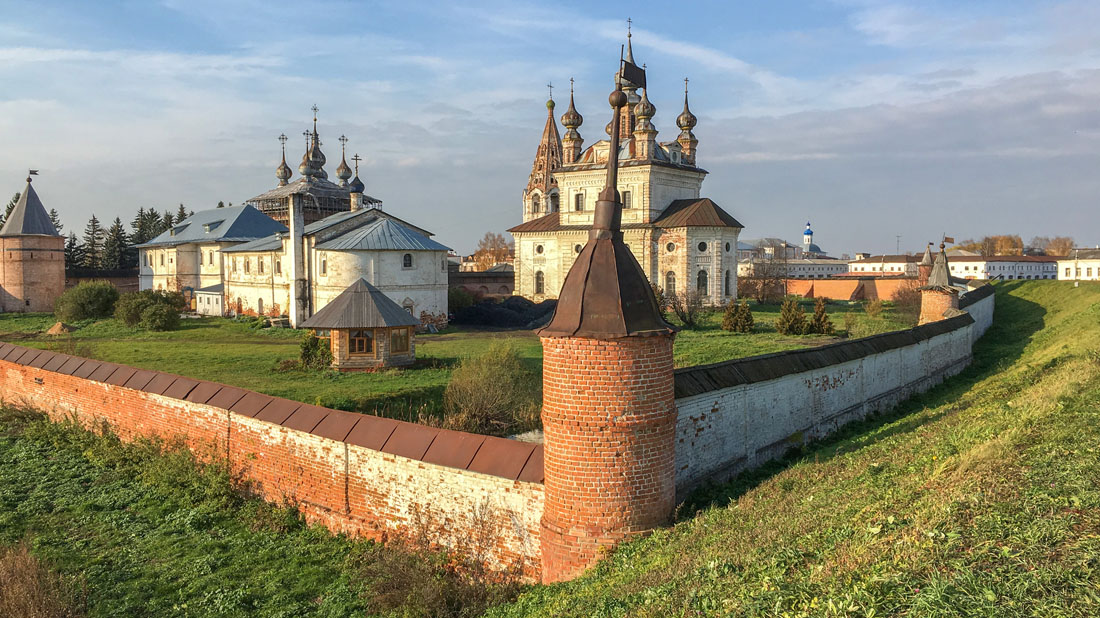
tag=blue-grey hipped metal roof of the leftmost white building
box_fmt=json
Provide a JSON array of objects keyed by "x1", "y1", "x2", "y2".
[{"x1": 138, "y1": 205, "x2": 286, "y2": 247}]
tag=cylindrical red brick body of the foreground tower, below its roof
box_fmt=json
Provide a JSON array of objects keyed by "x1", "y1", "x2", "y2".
[{"x1": 542, "y1": 335, "x2": 677, "y2": 583}]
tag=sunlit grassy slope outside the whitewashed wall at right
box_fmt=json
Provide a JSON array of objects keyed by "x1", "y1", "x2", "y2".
[{"x1": 492, "y1": 282, "x2": 1100, "y2": 617}]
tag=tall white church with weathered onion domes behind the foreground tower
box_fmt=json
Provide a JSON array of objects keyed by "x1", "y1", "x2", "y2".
[{"x1": 508, "y1": 40, "x2": 743, "y2": 305}]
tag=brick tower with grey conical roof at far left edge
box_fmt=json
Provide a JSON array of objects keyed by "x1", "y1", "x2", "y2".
[{"x1": 0, "y1": 170, "x2": 65, "y2": 313}]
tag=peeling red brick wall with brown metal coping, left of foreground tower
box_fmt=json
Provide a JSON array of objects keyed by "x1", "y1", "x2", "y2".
[{"x1": 0, "y1": 343, "x2": 543, "y2": 578}]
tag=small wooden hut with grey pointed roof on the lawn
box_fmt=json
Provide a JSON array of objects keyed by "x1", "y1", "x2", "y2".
[{"x1": 301, "y1": 278, "x2": 420, "y2": 371}]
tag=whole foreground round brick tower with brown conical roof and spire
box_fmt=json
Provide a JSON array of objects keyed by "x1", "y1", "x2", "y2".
[{"x1": 539, "y1": 76, "x2": 677, "y2": 583}]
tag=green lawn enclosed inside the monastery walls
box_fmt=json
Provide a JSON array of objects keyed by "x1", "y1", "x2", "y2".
[{"x1": 0, "y1": 304, "x2": 906, "y2": 420}]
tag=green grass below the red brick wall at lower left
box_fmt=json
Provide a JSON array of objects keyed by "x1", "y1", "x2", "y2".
[{"x1": 0, "y1": 408, "x2": 514, "y2": 618}]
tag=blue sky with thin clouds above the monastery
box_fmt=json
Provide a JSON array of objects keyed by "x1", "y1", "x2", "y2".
[{"x1": 0, "y1": 0, "x2": 1100, "y2": 256}]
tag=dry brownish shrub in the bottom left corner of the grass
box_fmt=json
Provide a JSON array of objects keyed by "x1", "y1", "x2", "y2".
[{"x1": 0, "y1": 544, "x2": 87, "y2": 618}]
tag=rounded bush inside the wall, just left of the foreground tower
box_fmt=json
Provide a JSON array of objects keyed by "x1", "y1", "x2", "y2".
[{"x1": 443, "y1": 341, "x2": 542, "y2": 435}]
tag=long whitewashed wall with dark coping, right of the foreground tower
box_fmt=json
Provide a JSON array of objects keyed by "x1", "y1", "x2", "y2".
[{"x1": 675, "y1": 286, "x2": 993, "y2": 497}]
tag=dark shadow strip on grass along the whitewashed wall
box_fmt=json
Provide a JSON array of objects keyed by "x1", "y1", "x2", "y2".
[{"x1": 677, "y1": 282, "x2": 1046, "y2": 520}]
